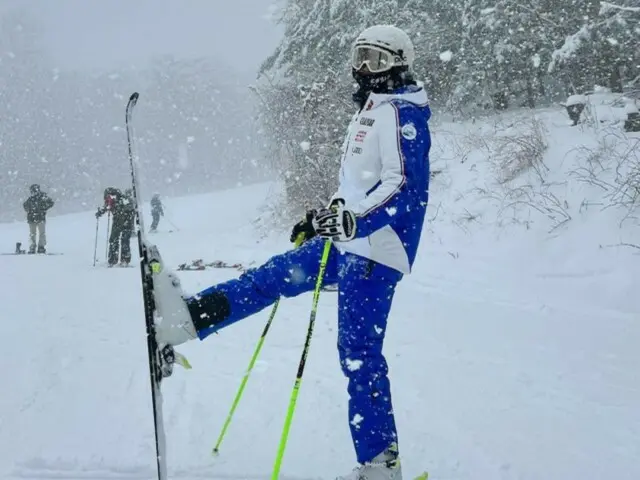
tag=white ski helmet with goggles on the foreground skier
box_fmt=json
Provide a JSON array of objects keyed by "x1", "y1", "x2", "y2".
[{"x1": 351, "y1": 25, "x2": 415, "y2": 73}]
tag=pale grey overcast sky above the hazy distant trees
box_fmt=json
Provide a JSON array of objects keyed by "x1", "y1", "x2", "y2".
[{"x1": 0, "y1": 0, "x2": 281, "y2": 74}]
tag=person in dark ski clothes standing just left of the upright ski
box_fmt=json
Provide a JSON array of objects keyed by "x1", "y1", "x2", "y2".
[{"x1": 96, "y1": 187, "x2": 135, "y2": 267}]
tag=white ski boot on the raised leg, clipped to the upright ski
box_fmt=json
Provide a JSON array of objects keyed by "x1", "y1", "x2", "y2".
[{"x1": 148, "y1": 246, "x2": 198, "y2": 348}]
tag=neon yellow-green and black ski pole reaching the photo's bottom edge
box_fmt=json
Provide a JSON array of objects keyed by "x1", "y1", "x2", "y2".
[{"x1": 271, "y1": 240, "x2": 331, "y2": 480}]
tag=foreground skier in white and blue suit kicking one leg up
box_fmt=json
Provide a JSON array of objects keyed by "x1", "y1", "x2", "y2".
[{"x1": 154, "y1": 25, "x2": 431, "y2": 480}]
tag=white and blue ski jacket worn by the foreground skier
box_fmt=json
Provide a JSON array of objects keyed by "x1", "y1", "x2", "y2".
[{"x1": 333, "y1": 86, "x2": 431, "y2": 274}]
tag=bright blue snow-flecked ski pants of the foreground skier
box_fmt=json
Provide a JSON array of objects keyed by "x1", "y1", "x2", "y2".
[{"x1": 190, "y1": 237, "x2": 402, "y2": 463}]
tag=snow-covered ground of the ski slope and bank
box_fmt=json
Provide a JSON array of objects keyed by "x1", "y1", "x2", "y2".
[{"x1": 0, "y1": 105, "x2": 640, "y2": 480}]
